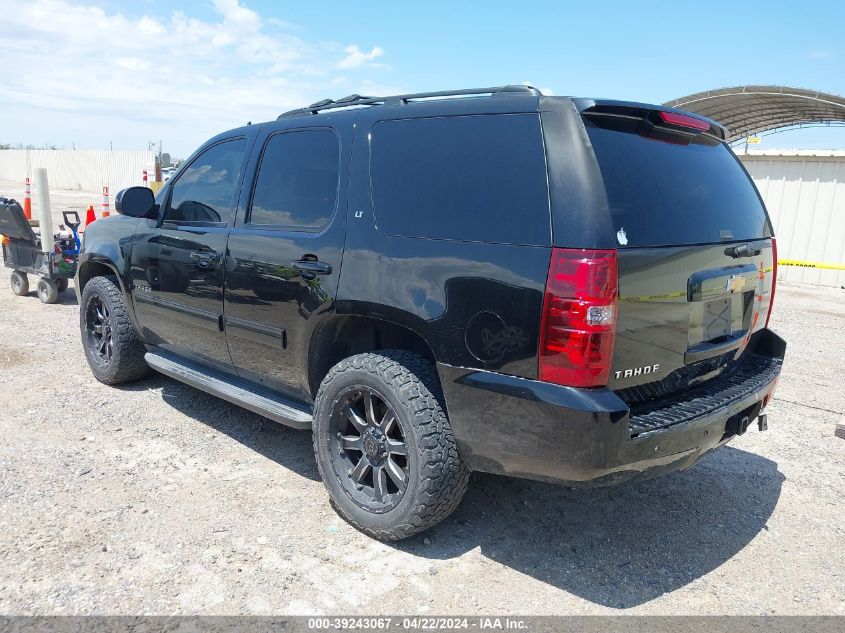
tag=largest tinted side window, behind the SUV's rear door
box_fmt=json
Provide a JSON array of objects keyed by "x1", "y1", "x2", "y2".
[{"x1": 371, "y1": 114, "x2": 551, "y2": 245}]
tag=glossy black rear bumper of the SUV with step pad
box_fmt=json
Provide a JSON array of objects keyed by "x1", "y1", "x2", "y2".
[{"x1": 438, "y1": 330, "x2": 786, "y2": 485}]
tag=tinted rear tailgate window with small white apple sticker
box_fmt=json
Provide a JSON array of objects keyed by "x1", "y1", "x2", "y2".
[{"x1": 585, "y1": 117, "x2": 771, "y2": 246}]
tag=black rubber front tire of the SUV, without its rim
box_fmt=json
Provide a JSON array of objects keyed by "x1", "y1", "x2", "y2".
[{"x1": 79, "y1": 276, "x2": 152, "y2": 385}]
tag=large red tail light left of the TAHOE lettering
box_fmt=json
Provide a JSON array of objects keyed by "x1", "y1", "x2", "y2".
[{"x1": 539, "y1": 248, "x2": 619, "y2": 387}]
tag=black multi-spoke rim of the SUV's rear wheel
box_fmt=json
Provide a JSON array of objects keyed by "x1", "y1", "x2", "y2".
[{"x1": 329, "y1": 387, "x2": 410, "y2": 513}]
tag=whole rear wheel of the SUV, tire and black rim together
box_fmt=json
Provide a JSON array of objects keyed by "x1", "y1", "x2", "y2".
[{"x1": 314, "y1": 350, "x2": 469, "y2": 541}]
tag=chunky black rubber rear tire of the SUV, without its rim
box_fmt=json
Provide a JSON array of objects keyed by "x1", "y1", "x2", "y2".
[{"x1": 314, "y1": 350, "x2": 470, "y2": 541}]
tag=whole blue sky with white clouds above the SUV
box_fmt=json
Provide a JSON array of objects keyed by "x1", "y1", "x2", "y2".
[{"x1": 0, "y1": 0, "x2": 845, "y2": 156}]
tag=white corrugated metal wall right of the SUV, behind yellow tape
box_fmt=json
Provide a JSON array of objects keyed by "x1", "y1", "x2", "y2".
[{"x1": 739, "y1": 152, "x2": 845, "y2": 287}]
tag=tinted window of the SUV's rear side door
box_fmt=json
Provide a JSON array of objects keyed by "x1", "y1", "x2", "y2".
[{"x1": 249, "y1": 130, "x2": 340, "y2": 228}]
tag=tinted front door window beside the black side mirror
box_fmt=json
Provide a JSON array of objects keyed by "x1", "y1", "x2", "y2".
[{"x1": 164, "y1": 139, "x2": 246, "y2": 224}]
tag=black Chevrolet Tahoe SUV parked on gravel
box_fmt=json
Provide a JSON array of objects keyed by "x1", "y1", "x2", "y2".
[{"x1": 76, "y1": 86, "x2": 785, "y2": 539}]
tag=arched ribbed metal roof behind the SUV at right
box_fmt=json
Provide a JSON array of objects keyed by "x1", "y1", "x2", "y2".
[{"x1": 663, "y1": 86, "x2": 845, "y2": 143}]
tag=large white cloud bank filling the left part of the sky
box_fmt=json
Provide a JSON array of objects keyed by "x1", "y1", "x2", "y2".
[{"x1": 0, "y1": 0, "x2": 384, "y2": 155}]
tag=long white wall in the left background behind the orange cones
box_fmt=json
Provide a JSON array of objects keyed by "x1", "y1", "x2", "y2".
[{"x1": 0, "y1": 149, "x2": 155, "y2": 195}]
